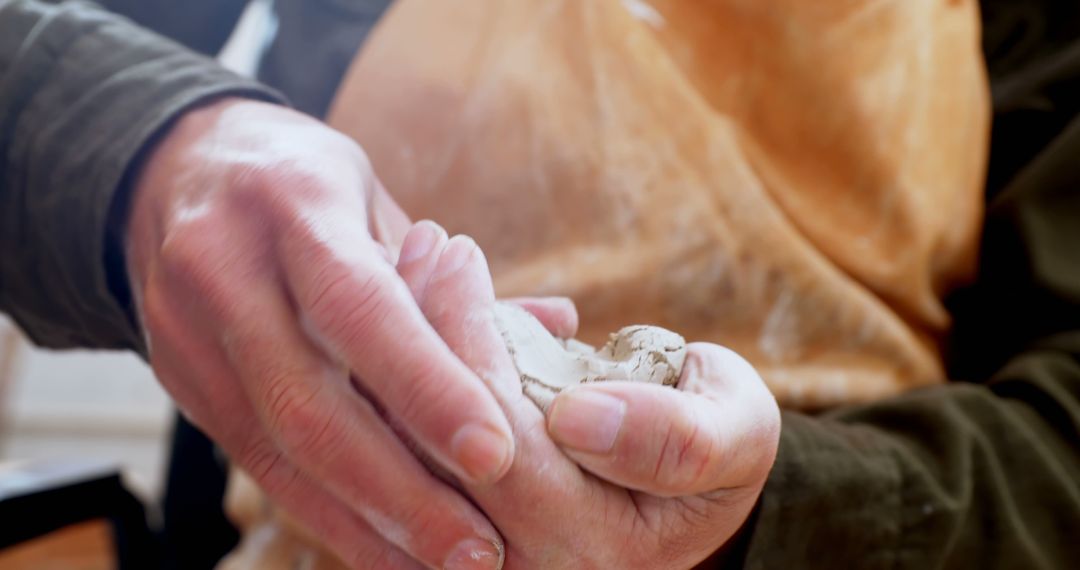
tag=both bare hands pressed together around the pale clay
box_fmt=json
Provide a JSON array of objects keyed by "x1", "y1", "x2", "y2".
[{"x1": 127, "y1": 99, "x2": 780, "y2": 568}]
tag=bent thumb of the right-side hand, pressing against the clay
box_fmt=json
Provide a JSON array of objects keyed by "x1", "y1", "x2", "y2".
[{"x1": 548, "y1": 344, "x2": 779, "y2": 497}]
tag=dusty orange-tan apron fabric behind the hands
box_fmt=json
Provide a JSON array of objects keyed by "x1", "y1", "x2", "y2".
[{"x1": 329, "y1": 0, "x2": 989, "y2": 407}]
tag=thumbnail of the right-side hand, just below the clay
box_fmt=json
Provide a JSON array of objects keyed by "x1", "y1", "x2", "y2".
[{"x1": 548, "y1": 389, "x2": 626, "y2": 453}]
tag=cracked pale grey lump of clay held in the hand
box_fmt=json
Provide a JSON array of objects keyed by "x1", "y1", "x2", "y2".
[{"x1": 495, "y1": 303, "x2": 686, "y2": 411}]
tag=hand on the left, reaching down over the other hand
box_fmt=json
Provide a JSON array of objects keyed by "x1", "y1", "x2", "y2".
[{"x1": 126, "y1": 99, "x2": 572, "y2": 568}]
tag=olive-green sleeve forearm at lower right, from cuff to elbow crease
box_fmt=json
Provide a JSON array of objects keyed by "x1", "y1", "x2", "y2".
[{"x1": 745, "y1": 334, "x2": 1080, "y2": 570}]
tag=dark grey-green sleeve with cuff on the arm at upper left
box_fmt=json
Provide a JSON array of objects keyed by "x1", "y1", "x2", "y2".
[{"x1": 0, "y1": 0, "x2": 278, "y2": 349}]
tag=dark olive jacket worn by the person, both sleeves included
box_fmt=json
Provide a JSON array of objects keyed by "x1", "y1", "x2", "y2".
[{"x1": 0, "y1": 0, "x2": 1080, "y2": 570}]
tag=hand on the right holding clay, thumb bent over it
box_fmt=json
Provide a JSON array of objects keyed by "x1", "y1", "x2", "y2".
[{"x1": 397, "y1": 222, "x2": 780, "y2": 569}]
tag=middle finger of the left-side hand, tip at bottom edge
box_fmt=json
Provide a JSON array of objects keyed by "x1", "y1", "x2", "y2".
[{"x1": 227, "y1": 282, "x2": 501, "y2": 567}]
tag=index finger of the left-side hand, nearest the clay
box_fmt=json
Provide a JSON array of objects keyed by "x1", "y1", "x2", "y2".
[{"x1": 280, "y1": 213, "x2": 514, "y2": 484}]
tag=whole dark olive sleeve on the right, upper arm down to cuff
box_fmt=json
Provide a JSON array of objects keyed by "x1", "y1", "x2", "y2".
[{"x1": 729, "y1": 0, "x2": 1080, "y2": 570}]
